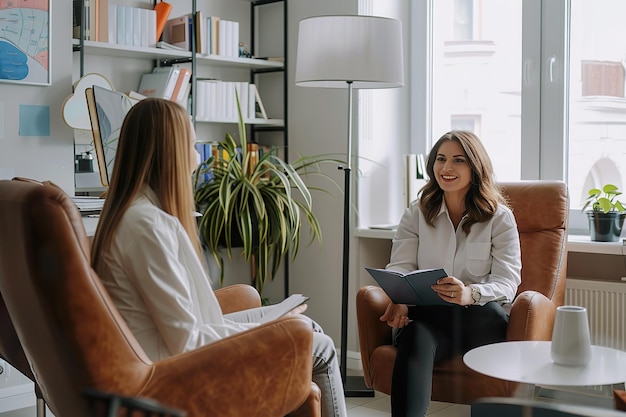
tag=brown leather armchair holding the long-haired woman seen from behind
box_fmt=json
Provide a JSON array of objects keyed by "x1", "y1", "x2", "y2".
[{"x1": 0, "y1": 180, "x2": 321, "y2": 417}]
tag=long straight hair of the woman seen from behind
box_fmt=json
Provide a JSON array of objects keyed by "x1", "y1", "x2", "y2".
[{"x1": 91, "y1": 98, "x2": 201, "y2": 271}]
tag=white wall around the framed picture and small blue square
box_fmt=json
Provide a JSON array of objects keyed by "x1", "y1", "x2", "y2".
[{"x1": 0, "y1": 1, "x2": 74, "y2": 194}]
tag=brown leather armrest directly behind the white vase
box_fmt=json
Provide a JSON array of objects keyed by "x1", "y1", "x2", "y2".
[{"x1": 506, "y1": 291, "x2": 556, "y2": 341}]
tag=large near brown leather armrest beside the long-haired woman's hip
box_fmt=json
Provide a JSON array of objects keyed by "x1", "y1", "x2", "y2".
[{"x1": 145, "y1": 316, "x2": 313, "y2": 417}]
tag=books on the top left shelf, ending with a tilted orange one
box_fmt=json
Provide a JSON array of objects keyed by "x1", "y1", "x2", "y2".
[{"x1": 74, "y1": 0, "x2": 171, "y2": 47}]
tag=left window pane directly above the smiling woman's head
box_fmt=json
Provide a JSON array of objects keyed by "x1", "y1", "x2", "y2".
[{"x1": 427, "y1": 0, "x2": 522, "y2": 180}]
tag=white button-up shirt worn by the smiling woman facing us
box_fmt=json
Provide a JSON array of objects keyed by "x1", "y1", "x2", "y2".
[{"x1": 387, "y1": 200, "x2": 522, "y2": 313}]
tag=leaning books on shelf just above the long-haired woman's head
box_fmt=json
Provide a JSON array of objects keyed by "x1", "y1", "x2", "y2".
[{"x1": 137, "y1": 65, "x2": 191, "y2": 107}]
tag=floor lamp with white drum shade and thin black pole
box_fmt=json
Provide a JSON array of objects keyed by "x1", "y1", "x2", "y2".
[{"x1": 296, "y1": 15, "x2": 404, "y2": 397}]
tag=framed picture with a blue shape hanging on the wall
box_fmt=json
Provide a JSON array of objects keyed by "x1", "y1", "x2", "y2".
[{"x1": 0, "y1": 0, "x2": 52, "y2": 85}]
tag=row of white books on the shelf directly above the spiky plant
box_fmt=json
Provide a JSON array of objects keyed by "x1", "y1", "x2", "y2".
[{"x1": 196, "y1": 79, "x2": 268, "y2": 122}]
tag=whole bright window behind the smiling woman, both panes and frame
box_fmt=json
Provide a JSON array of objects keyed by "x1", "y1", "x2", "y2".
[{"x1": 411, "y1": 0, "x2": 626, "y2": 233}]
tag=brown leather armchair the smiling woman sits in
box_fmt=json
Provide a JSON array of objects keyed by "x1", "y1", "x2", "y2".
[{"x1": 356, "y1": 181, "x2": 569, "y2": 404}]
